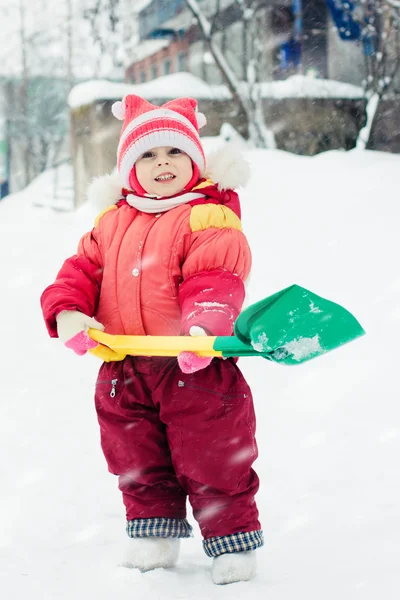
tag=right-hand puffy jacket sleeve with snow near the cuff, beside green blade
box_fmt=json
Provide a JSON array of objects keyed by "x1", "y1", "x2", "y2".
[{"x1": 179, "y1": 205, "x2": 251, "y2": 335}]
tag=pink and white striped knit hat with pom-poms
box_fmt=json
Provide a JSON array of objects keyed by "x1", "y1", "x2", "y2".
[{"x1": 111, "y1": 94, "x2": 207, "y2": 189}]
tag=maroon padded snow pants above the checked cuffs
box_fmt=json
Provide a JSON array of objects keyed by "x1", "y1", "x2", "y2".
[{"x1": 95, "y1": 357, "x2": 260, "y2": 539}]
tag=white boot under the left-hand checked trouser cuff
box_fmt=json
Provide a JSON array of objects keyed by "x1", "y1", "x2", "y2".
[{"x1": 123, "y1": 537, "x2": 181, "y2": 572}]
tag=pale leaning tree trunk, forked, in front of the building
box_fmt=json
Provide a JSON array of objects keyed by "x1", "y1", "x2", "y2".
[{"x1": 185, "y1": 0, "x2": 276, "y2": 148}]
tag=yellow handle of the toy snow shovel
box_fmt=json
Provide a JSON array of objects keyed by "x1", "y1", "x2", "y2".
[{"x1": 88, "y1": 329, "x2": 222, "y2": 362}]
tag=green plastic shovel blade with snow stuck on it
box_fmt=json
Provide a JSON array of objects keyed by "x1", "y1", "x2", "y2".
[{"x1": 228, "y1": 285, "x2": 365, "y2": 365}]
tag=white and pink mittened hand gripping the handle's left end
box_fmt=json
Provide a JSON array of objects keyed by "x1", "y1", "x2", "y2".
[{"x1": 56, "y1": 310, "x2": 104, "y2": 356}]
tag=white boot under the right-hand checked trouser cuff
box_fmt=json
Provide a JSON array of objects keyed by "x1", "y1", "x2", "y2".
[{"x1": 211, "y1": 550, "x2": 257, "y2": 585}]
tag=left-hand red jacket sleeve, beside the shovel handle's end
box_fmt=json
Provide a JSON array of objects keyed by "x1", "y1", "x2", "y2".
[{"x1": 40, "y1": 229, "x2": 103, "y2": 337}]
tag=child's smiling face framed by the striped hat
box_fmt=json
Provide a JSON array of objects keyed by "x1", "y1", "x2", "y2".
[{"x1": 136, "y1": 146, "x2": 193, "y2": 196}]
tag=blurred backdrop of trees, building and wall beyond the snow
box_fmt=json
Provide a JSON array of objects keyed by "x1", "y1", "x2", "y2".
[{"x1": 0, "y1": 0, "x2": 400, "y2": 210}]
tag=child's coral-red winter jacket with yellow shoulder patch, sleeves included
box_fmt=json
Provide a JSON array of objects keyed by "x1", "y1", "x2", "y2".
[{"x1": 41, "y1": 182, "x2": 251, "y2": 337}]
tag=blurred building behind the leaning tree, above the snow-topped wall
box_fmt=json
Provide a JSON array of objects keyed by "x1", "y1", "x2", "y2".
[{"x1": 125, "y1": 0, "x2": 363, "y2": 85}]
